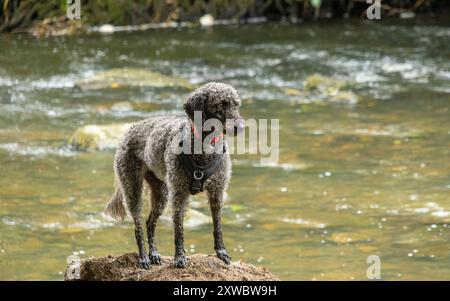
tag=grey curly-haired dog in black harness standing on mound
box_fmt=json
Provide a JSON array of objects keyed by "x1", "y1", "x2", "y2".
[{"x1": 105, "y1": 83, "x2": 244, "y2": 269}]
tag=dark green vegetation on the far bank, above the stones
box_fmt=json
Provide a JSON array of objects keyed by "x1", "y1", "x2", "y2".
[{"x1": 0, "y1": 0, "x2": 450, "y2": 32}]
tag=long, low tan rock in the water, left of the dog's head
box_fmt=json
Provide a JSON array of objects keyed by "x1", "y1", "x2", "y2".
[{"x1": 75, "y1": 68, "x2": 195, "y2": 90}]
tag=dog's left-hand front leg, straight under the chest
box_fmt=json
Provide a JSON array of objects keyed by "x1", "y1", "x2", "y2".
[{"x1": 173, "y1": 193, "x2": 189, "y2": 268}]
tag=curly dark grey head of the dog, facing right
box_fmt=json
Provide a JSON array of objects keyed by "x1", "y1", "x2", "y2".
[{"x1": 183, "y1": 82, "x2": 245, "y2": 135}]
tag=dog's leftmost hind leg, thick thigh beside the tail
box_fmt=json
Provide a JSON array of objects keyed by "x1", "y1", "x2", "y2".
[{"x1": 115, "y1": 151, "x2": 150, "y2": 269}]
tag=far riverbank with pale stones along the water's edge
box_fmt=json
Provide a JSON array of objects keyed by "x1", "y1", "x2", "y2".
[{"x1": 0, "y1": 0, "x2": 450, "y2": 36}]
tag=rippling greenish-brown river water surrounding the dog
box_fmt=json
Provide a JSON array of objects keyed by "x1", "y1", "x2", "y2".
[{"x1": 0, "y1": 23, "x2": 450, "y2": 280}]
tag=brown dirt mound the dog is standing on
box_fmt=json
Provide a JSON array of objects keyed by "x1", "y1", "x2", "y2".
[{"x1": 64, "y1": 253, "x2": 279, "y2": 281}]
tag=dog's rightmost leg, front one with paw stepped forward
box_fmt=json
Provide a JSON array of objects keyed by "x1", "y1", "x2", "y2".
[{"x1": 208, "y1": 191, "x2": 231, "y2": 264}]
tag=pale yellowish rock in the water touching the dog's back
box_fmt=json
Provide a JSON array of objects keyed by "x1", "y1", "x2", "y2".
[{"x1": 69, "y1": 123, "x2": 132, "y2": 151}]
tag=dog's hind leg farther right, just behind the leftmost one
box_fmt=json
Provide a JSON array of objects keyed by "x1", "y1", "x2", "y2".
[{"x1": 144, "y1": 171, "x2": 167, "y2": 264}]
